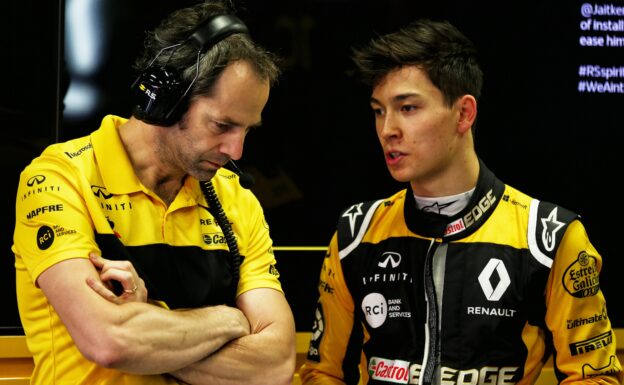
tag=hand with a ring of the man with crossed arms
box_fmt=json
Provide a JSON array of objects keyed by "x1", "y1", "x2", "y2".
[{"x1": 86, "y1": 253, "x2": 147, "y2": 305}]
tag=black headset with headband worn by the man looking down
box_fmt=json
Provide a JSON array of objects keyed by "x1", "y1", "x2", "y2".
[{"x1": 130, "y1": 14, "x2": 249, "y2": 126}]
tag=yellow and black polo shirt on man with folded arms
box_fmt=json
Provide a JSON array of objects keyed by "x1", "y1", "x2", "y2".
[{"x1": 12, "y1": 115, "x2": 281, "y2": 385}]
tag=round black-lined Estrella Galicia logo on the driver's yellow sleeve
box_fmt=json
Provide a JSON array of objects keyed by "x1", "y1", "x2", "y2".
[{"x1": 562, "y1": 251, "x2": 600, "y2": 298}]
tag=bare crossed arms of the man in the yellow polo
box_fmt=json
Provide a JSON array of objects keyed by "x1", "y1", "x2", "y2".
[{"x1": 37, "y1": 252, "x2": 295, "y2": 384}]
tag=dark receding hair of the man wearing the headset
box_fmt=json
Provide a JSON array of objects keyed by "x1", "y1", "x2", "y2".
[{"x1": 134, "y1": 0, "x2": 280, "y2": 98}]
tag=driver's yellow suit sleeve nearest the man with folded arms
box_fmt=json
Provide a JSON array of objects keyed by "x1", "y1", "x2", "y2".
[{"x1": 299, "y1": 234, "x2": 361, "y2": 385}]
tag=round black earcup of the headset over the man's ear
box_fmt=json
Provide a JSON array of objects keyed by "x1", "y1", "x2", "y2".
[{"x1": 131, "y1": 66, "x2": 185, "y2": 126}]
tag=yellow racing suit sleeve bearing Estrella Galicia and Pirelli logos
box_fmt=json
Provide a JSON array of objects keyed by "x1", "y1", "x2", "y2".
[{"x1": 546, "y1": 220, "x2": 624, "y2": 384}]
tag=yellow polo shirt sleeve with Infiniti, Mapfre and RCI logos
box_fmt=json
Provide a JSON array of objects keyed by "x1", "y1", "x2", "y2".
[{"x1": 12, "y1": 151, "x2": 98, "y2": 282}]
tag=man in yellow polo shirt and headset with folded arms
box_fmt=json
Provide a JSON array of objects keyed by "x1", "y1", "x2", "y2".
[{"x1": 13, "y1": 2, "x2": 295, "y2": 385}]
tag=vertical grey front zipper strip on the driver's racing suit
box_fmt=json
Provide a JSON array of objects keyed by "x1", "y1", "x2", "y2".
[{"x1": 419, "y1": 239, "x2": 439, "y2": 385}]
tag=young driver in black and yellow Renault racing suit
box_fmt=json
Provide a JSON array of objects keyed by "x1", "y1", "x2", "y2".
[{"x1": 301, "y1": 20, "x2": 622, "y2": 385}]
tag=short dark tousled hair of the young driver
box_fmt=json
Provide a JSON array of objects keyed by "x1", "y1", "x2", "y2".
[{"x1": 352, "y1": 19, "x2": 483, "y2": 106}]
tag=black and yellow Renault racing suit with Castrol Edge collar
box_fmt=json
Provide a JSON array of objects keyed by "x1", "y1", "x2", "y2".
[{"x1": 300, "y1": 162, "x2": 623, "y2": 385}]
